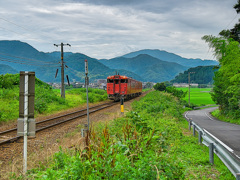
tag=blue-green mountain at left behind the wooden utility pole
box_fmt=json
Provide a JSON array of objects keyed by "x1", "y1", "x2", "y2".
[{"x1": 0, "y1": 41, "x2": 143, "y2": 82}]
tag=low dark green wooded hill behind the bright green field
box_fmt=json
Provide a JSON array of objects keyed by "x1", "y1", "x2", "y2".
[{"x1": 171, "y1": 66, "x2": 217, "y2": 84}]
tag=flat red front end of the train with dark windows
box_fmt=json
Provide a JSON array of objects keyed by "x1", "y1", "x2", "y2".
[{"x1": 107, "y1": 75, "x2": 128, "y2": 101}]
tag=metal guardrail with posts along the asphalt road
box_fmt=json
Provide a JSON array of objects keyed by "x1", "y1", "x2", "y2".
[{"x1": 185, "y1": 112, "x2": 240, "y2": 180}]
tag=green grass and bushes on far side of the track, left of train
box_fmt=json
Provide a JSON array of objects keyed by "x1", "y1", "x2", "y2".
[{"x1": 0, "y1": 74, "x2": 107, "y2": 122}]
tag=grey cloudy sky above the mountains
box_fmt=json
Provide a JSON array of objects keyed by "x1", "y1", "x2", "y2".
[{"x1": 0, "y1": 0, "x2": 239, "y2": 59}]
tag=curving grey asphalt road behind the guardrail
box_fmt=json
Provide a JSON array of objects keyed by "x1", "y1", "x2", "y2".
[{"x1": 185, "y1": 107, "x2": 240, "y2": 159}]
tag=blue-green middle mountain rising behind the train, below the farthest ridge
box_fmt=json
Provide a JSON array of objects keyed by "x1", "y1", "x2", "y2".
[{"x1": 100, "y1": 54, "x2": 187, "y2": 82}]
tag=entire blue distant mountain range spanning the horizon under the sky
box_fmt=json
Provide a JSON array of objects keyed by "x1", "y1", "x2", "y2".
[{"x1": 0, "y1": 41, "x2": 218, "y2": 82}]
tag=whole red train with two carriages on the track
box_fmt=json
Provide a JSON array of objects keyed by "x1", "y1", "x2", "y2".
[{"x1": 107, "y1": 75, "x2": 142, "y2": 101}]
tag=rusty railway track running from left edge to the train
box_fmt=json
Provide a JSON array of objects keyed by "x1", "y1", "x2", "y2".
[{"x1": 0, "y1": 102, "x2": 116, "y2": 146}]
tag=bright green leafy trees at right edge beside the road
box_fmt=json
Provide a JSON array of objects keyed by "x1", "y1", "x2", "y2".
[{"x1": 202, "y1": 35, "x2": 240, "y2": 118}]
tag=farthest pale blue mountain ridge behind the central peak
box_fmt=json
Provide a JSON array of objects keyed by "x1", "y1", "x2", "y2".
[{"x1": 122, "y1": 49, "x2": 218, "y2": 67}]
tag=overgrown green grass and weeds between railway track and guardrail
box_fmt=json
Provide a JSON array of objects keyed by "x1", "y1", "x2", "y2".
[{"x1": 12, "y1": 91, "x2": 234, "y2": 179}]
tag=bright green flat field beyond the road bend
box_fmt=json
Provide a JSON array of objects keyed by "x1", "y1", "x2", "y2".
[{"x1": 178, "y1": 88, "x2": 215, "y2": 106}]
